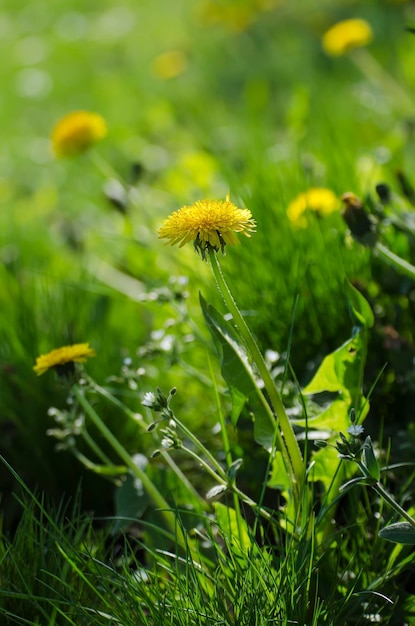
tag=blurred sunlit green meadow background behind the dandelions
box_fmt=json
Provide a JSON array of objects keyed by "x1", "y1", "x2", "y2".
[{"x1": 0, "y1": 0, "x2": 415, "y2": 528}]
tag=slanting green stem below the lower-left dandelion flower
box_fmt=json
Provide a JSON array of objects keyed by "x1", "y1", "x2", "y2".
[{"x1": 72, "y1": 385, "x2": 181, "y2": 537}]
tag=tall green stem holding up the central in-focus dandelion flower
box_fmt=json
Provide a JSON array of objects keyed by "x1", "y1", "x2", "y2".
[{"x1": 208, "y1": 249, "x2": 304, "y2": 493}]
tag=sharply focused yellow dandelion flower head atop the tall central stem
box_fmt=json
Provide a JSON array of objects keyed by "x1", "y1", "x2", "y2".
[{"x1": 158, "y1": 196, "x2": 256, "y2": 259}]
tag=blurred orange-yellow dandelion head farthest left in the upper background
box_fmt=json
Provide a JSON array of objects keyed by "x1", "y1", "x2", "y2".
[{"x1": 51, "y1": 111, "x2": 107, "y2": 157}]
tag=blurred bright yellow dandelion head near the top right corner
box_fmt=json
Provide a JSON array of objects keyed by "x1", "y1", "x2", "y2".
[{"x1": 322, "y1": 18, "x2": 373, "y2": 57}]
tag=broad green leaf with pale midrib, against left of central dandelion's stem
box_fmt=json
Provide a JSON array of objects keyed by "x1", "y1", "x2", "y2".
[{"x1": 200, "y1": 295, "x2": 281, "y2": 450}]
